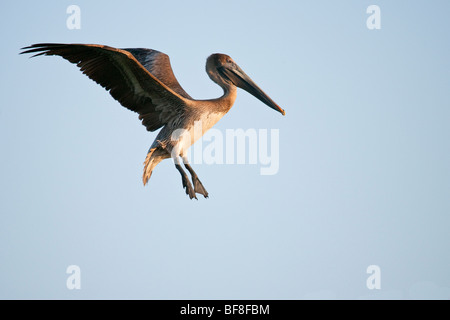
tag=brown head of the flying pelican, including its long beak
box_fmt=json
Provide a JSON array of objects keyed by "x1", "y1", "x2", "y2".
[{"x1": 206, "y1": 53, "x2": 285, "y2": 116}]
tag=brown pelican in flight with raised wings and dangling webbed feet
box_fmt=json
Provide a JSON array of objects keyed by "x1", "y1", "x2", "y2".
[{"x1": 21, "y1": 43, "x2": 285, "y2": 199}]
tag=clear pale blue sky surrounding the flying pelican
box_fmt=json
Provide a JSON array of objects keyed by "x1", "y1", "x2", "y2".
[{"x1": 0, "y1": 0, "x2": 450, "y2": 299}]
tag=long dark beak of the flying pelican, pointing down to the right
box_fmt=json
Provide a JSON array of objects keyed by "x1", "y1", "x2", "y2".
[{"x1": 219, "y1": 64, "x2": 286, "y2": 116}]
